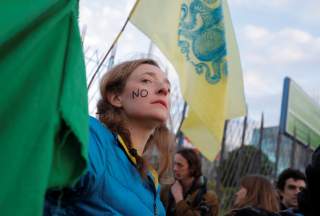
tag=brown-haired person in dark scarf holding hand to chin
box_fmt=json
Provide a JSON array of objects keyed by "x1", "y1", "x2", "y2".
[{"x1": 161, "y1": 148, "x2": 219, "y2": 216}]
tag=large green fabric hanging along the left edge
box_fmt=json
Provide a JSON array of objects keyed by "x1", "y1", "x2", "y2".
[{"x1": 0, "y1": 0, "x2": 88, "y2": 216}]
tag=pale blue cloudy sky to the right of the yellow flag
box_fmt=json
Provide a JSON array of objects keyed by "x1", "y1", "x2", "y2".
[{"x1": 229, "y1": 0, "x2": 320, "y2": 124}]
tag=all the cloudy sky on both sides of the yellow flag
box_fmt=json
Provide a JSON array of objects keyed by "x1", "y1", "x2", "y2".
[{"x1": 80, "y1": 0, "x2": 320, "y2": 125}]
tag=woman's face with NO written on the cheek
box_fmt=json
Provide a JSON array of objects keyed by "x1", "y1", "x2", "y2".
[{"x1": 115, "y1": 64, "x2": 170, "y2": 124}]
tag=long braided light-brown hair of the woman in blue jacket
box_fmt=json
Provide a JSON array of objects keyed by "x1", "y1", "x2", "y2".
[{"x1": 97, "y1": 58, "x2": 174, "y2": 179}]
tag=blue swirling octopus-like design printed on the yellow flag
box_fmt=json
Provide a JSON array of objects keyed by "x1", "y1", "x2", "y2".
[{"x1": 178, "y1": 0, "x2": 227, "y2": 84}]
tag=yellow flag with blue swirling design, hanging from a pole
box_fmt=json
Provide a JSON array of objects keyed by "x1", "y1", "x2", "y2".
[{"x1": 131, "y1": 0, "x2": 245, "y2": 160}]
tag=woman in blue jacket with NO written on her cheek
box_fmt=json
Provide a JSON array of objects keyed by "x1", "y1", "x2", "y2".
[{"x1": 45, "y1": 59, "x2": 171, "y2": 216}]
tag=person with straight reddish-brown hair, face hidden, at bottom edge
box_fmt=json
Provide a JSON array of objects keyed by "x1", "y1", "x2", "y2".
[{"x1": 227, "y1": 175, "x2": 279, "y2": 216}]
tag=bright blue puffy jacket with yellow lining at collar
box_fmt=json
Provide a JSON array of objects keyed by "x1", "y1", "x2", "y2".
[{"x1": 44, "y1": 117, "x2": 165, "y2": 216}]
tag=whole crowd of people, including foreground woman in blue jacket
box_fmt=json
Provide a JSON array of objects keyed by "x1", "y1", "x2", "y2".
[{"x1": 44, "y1": 59, "x2": 320, "y2": 216}]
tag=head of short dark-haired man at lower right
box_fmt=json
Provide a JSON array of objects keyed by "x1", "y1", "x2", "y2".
[{"x1": 277, "y1": 168, "x2": 306, "y2": 211}]
